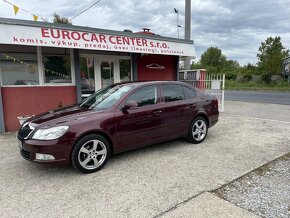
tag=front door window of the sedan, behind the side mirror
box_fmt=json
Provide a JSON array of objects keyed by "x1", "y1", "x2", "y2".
[{"x1": 127, "y1": 86, "x2": 157, "y2": 107}]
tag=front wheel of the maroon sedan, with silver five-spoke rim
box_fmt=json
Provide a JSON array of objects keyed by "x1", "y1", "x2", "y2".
[{"x1": 71, "y1": 134, "x2": 110, "y2": 173}]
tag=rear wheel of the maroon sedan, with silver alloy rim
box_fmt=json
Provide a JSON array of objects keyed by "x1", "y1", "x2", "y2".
[{"x1": 188, "y1": 116, "x2": 208, "y2": 144}]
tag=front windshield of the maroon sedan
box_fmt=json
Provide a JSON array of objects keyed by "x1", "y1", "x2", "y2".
[{"x1": 80, "y1": 85, "x2": 133, "y2": 110}]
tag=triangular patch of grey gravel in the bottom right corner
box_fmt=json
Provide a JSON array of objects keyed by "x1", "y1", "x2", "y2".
[{"x1": 214, "y1": 153, "x2": 290, "y2": 218}]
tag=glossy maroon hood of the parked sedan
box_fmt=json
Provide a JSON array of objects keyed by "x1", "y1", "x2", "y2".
[{"x1": 27, "y1": 105, "x2": 95, "y2": 127}]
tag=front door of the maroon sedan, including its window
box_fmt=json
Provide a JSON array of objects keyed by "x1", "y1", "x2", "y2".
[{"x1": 115, "y1": 85, "x2": 162, "y2": 150}]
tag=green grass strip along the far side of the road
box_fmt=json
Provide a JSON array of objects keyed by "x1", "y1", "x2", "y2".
[{"x1": 225, "y1": 80, "x2": 290, "y2": 91}]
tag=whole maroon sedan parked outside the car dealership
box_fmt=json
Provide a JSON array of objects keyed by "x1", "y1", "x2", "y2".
[{"x1": 18, "y1": 81, "x2": 219, "y2": 173}]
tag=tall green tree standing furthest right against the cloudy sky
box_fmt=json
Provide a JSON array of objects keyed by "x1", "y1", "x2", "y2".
[{"x1": 257, "y1": 36, "x2": 289, "y2": 75}]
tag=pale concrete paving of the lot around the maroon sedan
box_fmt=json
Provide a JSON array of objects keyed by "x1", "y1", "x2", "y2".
[{"x1": 0, "y1": 102, "x2": 290, "y2": 217}]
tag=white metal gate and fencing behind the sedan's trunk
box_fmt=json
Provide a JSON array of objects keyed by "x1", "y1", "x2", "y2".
[{"x1": 178, "y1": 70, "x2": 225, "y2": 112}]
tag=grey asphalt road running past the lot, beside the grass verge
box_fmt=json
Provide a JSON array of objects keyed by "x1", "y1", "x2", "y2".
[{"x1": 225, "y1": 90, "x2": 290, "y2": 105}]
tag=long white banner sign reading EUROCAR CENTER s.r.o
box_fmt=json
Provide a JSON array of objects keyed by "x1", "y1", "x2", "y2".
[{"x1": 0, "y1": 24, "x2": 196, "y2": 57}]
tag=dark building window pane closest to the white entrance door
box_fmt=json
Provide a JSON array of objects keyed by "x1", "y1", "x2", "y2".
[{"x1": 42, "y1": 47, "x2": 72, "y2": 83}]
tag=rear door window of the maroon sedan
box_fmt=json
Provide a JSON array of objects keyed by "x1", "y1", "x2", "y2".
[{"x1": 162, "y1": 85, "x2": 184, "y2": 102}]
